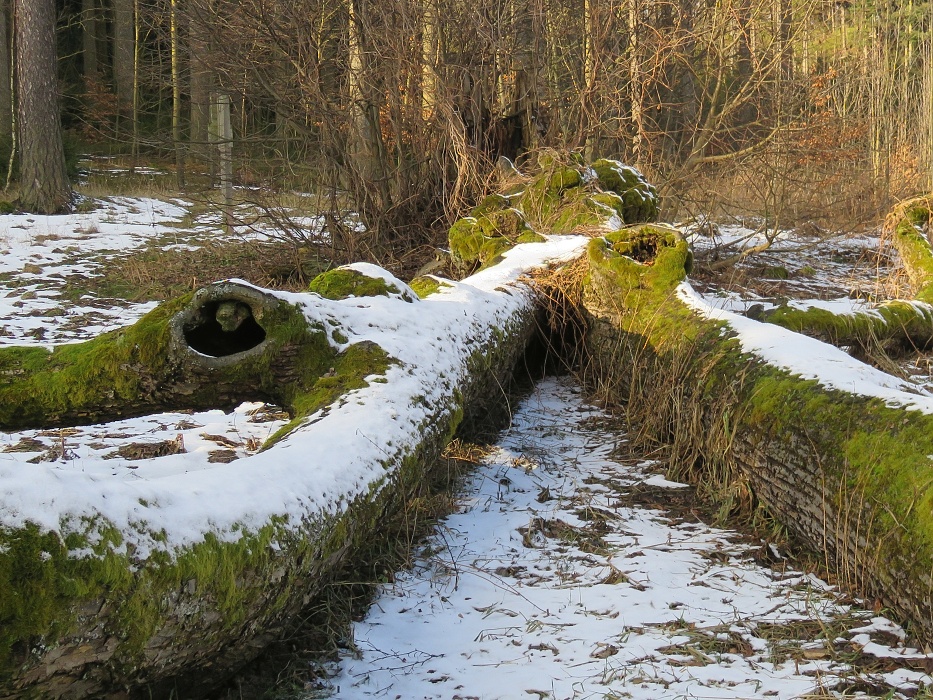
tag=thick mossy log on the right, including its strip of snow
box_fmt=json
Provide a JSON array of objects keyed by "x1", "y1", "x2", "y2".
[{"x1": 584, "y1": 225, "x2": 933, "y2": 644}]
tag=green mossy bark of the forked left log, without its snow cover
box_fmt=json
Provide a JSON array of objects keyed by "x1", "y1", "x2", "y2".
[{"x1": 0, "y1": 266, "x2": 536, "y2": 698}]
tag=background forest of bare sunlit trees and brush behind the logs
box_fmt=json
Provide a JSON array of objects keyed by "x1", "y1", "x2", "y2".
[{"x1": 0, "y1": 0, "x2": 933, "y2": 258}]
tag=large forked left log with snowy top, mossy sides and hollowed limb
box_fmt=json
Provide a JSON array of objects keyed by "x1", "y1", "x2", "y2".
[{"x1": 0, "y1": 238, "x2": 583, "y2": 697}]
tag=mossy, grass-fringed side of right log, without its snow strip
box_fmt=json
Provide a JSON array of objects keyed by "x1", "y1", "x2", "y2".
[{"x1": 585, "y1": 226, "x2": 933, "y2": 639}]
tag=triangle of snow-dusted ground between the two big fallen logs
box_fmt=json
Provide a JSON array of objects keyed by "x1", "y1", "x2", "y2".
[{"x1": 316, "y1": 379, "x2": 933, "y2": 700}]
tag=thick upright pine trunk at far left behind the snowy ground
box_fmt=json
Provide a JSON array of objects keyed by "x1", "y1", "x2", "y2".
[{"x1": 14, "y1": 0, "x2": 71, "y2": 214}]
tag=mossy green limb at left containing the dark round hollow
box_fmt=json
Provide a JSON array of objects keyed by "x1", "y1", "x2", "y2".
[{"x1": 0, "y1": 283, "x2": 337, "y2": 430}]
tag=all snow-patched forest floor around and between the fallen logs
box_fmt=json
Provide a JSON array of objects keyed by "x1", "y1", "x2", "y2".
[{"x1": 0, "y1": 163, "x2": 933, "y2": 700}]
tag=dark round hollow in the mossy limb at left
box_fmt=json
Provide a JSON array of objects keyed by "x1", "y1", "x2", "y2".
[{"x1": 185, "y1": 299, "x2": 266, "y2": 357}]
